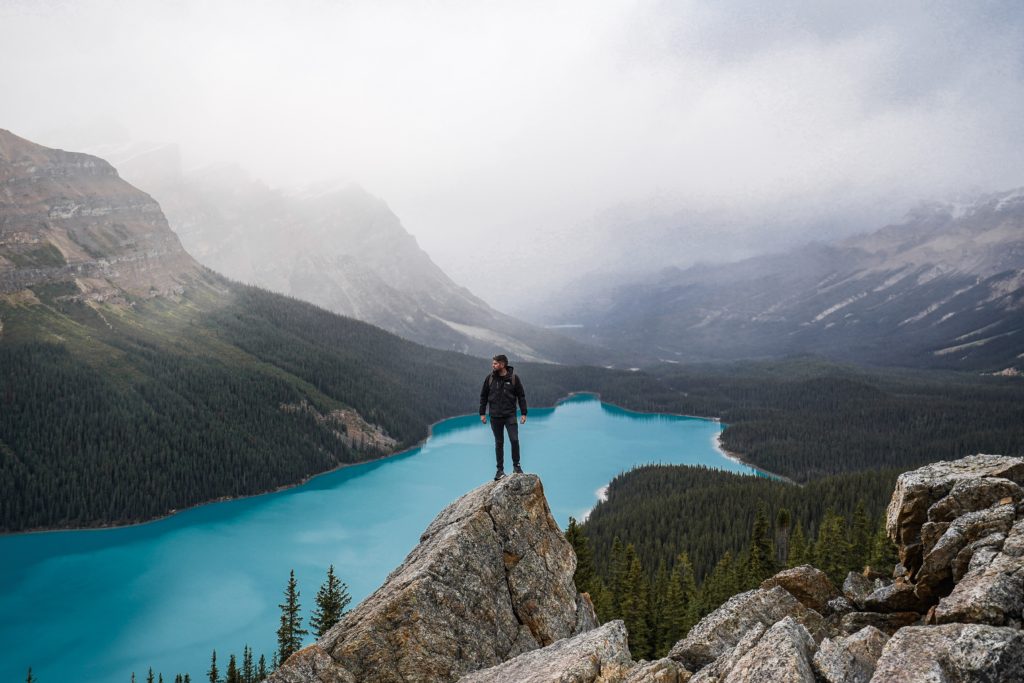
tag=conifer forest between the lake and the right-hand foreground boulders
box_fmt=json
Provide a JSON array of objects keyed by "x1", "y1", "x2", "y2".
[{"x1": 566, "y1": 466, "x2": 897, "y2": 658}]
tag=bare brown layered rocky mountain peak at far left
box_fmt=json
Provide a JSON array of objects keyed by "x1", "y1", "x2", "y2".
[{"x1": 0, "y1": 130, "x2": 202, "y2": 299}]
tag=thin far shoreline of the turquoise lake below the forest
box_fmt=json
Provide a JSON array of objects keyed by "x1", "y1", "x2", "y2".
[{"x1": 0, "y1": 391, "x2": 782, "y2": 538}]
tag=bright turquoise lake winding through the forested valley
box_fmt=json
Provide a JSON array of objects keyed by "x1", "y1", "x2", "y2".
[{"x1": 0, "y1": 396, "x2": 752, "y2": 683}]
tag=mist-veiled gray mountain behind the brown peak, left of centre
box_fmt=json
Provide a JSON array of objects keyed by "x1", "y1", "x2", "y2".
[{"x1": 95, "y1": 145, "x2": 607, "y2": 362}]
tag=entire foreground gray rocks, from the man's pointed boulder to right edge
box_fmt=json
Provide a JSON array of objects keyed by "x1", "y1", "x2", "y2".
[{"x1": 271, "y1": 455, "x2": 1024, "y2": 683}]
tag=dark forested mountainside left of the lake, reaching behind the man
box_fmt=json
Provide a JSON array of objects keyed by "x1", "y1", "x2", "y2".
[{"x1": 0, "y1": 273, "x2": 656, "y2": 531}]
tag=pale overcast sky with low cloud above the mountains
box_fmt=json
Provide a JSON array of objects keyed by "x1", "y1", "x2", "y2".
[{"x1": 0, "y1": 0, "x2": 1024, "y2": 308}]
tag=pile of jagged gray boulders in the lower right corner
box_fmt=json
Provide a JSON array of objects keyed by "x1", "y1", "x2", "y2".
[{"x1": 670, "y1": 455, "x2": 1024, "y2": 683}]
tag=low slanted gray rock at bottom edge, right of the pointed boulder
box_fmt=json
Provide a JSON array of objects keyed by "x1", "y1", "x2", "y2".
[{"x1": 460, "y1": 621, "x2": 634, "y2": 683}]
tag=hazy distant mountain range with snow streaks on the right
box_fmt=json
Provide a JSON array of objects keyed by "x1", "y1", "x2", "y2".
[{"x1": 544, "y1": 189, "x2": 1024, "y2": 373}]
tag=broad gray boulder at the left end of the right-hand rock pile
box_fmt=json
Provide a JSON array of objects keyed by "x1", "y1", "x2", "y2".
[{"x1": 669, "y1": 586, "x2": 824, "y2": 671}]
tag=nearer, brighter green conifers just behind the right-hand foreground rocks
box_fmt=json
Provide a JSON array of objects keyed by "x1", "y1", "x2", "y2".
[{"x1": 565, "y1": 479, "x2": 897, "y2": 659}]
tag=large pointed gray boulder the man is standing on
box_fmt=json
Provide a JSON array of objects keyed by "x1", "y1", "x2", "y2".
[{"x1": 270, "y1": 474, "x2": 596, "y2": 683}]
